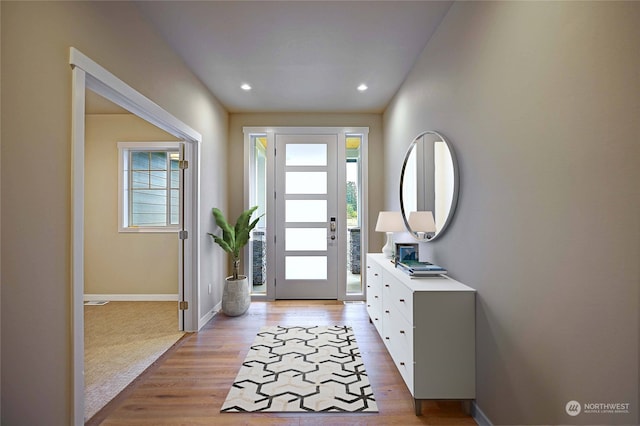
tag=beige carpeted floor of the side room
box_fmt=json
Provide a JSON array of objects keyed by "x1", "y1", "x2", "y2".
[{"x1": 84, "y1": 302, "x2": 184, "y2": 419}]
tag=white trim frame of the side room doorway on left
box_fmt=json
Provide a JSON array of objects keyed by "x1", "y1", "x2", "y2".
[{"x1": 69, "y1": 47, "x2": 202, "y2": 425}]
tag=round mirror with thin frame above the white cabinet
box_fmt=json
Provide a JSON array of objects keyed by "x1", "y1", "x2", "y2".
[{"x1": 400, "y1": 130, "x2": 459, "y2": 241}]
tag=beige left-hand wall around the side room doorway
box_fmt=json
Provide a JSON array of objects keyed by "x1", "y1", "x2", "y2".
[{"x1": 0, "y1": 1, "x2": 228, "y2": 425}]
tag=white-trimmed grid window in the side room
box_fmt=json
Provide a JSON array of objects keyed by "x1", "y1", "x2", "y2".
[{"x1": 118, "y1": 142, "x2": 181, "y2": 232}]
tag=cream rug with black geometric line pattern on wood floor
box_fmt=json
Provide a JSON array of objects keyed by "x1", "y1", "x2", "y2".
[{"x1": 220, "y1": 326, "x2": 378, "y2": 413}]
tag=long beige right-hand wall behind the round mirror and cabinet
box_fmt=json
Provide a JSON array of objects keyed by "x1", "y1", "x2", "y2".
[{"x1": 384, "y1": 2, "x2": 640, "y2": 425}]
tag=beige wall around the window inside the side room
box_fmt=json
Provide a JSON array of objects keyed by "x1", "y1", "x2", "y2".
[{"x1": 84, "y1": 114, "x2": 179, "y2": 295}]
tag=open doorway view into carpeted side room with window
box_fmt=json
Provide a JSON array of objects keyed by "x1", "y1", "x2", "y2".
[{"x1": 84, "y1": 90, "x2": 184, "y2": 419}]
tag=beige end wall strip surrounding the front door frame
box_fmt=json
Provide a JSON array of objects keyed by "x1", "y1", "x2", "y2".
[{"x1": 229, "y1": 113, "x2": 384, "y2": 253}]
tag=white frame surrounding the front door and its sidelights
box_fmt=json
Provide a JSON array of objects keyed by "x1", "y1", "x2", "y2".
[{"x1": 242, "y1": 127, "x2": 369, "y2": 300}]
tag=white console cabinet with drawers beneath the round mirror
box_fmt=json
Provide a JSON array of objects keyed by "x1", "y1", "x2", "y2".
[{"x1": 367, "y1": 253, "x2": 476, "y2": 415}]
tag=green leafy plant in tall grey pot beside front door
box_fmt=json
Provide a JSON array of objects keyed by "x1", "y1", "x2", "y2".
[{"x1": 209, "y1": 206, "x2": 260, "y2": 316}]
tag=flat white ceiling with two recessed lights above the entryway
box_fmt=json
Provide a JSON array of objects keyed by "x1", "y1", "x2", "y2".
[{"x1": 136, "y1": 0, "x2": 452, "y2": 112}]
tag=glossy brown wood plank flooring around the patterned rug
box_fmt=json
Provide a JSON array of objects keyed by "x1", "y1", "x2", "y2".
[{"x1": 92, "y1": 301, "x2": 476, "y2": 426}]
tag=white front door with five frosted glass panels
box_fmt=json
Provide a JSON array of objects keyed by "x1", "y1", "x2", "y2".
[{"x1": 275, "y1": 134, "x2": 344, "y2": 299}]
